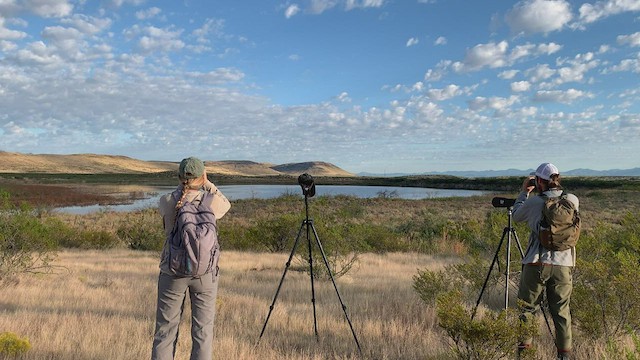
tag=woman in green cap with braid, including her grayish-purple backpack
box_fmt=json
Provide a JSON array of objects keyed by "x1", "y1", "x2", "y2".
[{"x1": 151, "y1": 157, "x2": 231, "y2": 360}]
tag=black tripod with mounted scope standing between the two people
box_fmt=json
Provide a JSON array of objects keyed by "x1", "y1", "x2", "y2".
[{"x1": 258, "y1": 174, "x2": 362, "y2": 353}]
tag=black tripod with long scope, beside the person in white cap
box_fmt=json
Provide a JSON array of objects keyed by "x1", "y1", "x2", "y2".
[{"x1": 471, "y1": 197, "x2": 553, "y2": 335}]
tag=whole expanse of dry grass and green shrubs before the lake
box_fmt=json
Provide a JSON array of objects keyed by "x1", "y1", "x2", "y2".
[{"x1": 0, "y1": 180, "x2": 640, "y2": 359}]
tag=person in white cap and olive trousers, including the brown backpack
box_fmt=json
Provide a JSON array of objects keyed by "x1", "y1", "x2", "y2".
[{"x1": 513, "y1": 163, "x2": 580, "y2": 359}]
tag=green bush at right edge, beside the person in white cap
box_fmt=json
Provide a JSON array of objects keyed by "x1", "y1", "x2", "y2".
[{"x1": 571, "y1": 213, "x2": 640, "y2": 339}]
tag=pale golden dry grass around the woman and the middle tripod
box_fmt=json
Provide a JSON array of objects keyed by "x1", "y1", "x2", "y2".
[{"x1": 0, "y1": 250, "x2": 460, "y2": 360}]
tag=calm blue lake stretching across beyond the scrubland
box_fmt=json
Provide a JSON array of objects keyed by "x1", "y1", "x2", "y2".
[{"x1": 55, "y1": 185, "x2": 486, "y2": 215}]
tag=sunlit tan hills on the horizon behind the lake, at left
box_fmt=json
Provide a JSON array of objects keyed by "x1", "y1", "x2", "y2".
[{"x1": 0, "y1": 151, "x2": 355, "y2": 176}]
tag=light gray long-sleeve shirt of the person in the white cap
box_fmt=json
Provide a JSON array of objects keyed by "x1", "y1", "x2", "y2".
[{"x1": 512, "y1": 189, "x2": 579, "y2": 266}]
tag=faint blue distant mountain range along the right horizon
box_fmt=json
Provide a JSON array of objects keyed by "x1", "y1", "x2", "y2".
[{"x1": 358, "y1": 168, "x2": 640, "y2": 178}]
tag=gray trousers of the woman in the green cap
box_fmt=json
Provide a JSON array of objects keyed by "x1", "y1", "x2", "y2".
[{"x1": 151, "y1": 272, "x2": 218, "y2": 360}]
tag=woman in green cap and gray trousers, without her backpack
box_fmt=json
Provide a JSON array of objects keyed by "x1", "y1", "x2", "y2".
[{"x1": 151, "y1": 157, "x2": 231, "y2": 360}]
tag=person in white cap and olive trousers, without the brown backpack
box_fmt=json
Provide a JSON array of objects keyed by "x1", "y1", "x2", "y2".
[{"x1": 513, "y1": 163, "x2": 579, "y2": 360}]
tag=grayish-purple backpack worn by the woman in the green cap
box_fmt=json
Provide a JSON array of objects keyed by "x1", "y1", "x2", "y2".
[{"x1": 167, "y1": 190, "x2": 220, "y2": 277}]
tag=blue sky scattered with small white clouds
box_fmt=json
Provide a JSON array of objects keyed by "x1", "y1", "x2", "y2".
[{"x1": 0, "y1": 0, "x2": 640, "y2": 174}]
